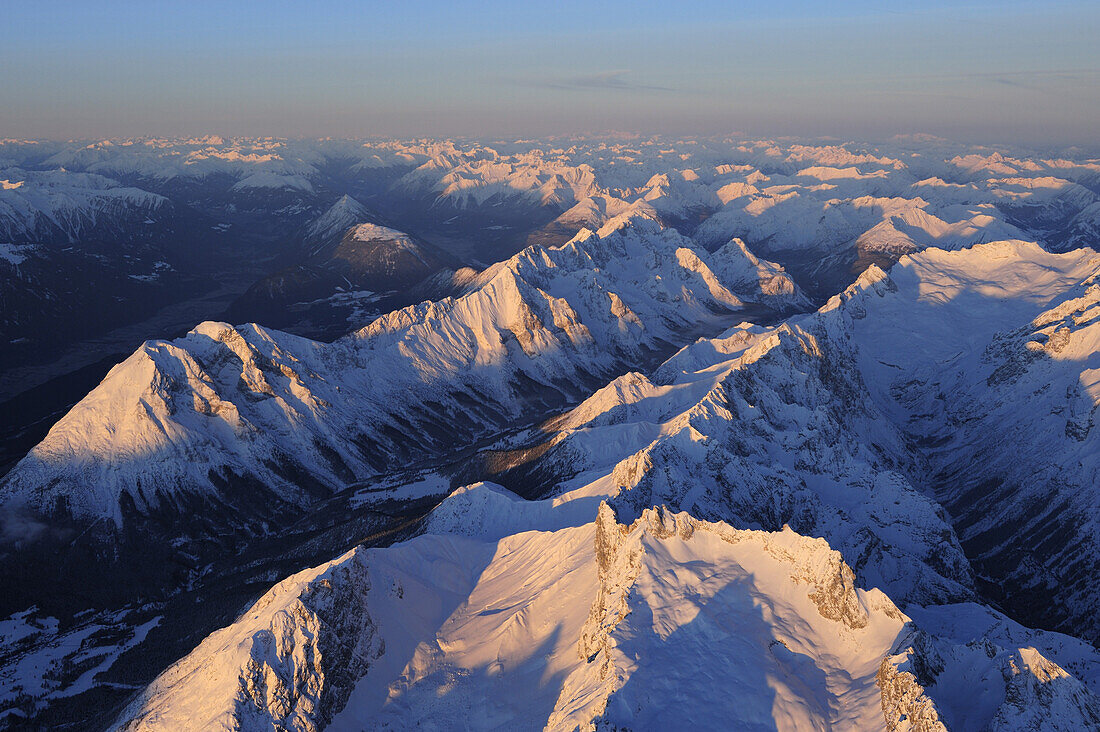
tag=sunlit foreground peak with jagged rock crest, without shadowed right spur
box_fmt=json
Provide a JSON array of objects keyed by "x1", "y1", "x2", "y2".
[{"x1": 111, "y1": 499, "x2": 904, "y2": 731}]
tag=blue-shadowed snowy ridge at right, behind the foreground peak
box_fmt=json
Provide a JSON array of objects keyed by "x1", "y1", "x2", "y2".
[{"x1": 525, "y1": 241, "x2": 1100, "y2": 633}]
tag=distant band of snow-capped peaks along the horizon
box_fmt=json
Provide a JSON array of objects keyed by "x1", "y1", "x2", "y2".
[{"x1": 0, "y1": 135, "x2": 1100, "y2": 269}]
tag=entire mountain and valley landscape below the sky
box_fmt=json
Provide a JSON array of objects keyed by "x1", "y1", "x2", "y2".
[{"x1": 0, "y1": 135, "x2": 1100, "y2": 732}]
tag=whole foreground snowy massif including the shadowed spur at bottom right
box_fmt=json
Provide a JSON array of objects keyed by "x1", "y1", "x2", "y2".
[{"x1": 109, "y1": 484, "x2": 1100, "y2": 731}]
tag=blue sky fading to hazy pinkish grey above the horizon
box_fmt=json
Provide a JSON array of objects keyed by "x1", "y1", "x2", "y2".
[{"x1": 0, "y1": 0, "x2": 1100, "y2": 145}]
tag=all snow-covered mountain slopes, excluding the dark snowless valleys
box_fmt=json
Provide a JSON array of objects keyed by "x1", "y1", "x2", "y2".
[{"x1": 0, "y1": 135, "x2": 1100, "y2": 730}]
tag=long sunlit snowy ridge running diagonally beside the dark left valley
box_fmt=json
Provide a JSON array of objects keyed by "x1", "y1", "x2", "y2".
[{"x1": 2, "y1": 214, "x2": 804, "y2": 525}]
